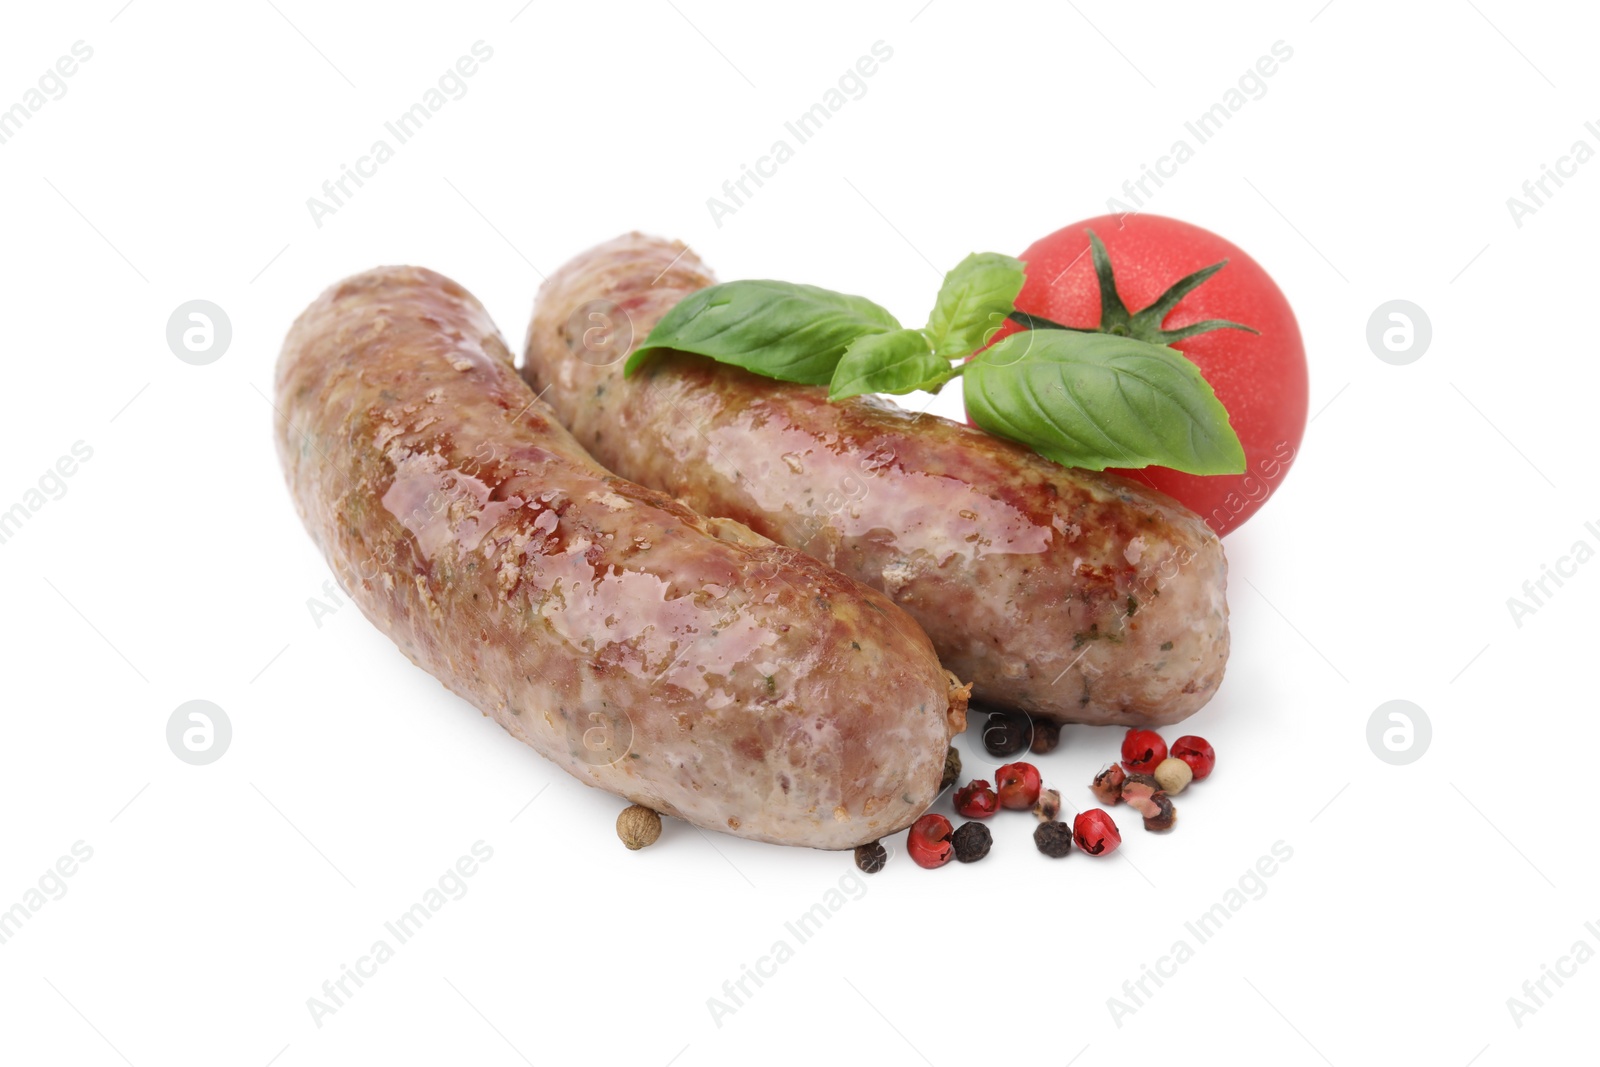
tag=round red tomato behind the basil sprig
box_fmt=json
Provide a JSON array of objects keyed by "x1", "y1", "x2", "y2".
[{"x1": 997, "y1": 214, "x2": 1307, "y2": 534}]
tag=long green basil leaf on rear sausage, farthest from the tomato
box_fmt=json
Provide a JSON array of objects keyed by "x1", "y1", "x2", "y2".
[{"x1": 622, "y1": 282, "x2": 899, "y2": 386}]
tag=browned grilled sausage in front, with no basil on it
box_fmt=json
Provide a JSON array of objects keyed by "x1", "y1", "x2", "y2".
[{"x1": 275, "y1": 267, "x2": 965, "y2": 849}]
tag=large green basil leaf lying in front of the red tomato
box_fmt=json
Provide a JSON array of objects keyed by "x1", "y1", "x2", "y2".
[{"x1": 963, "y1": 330, "x2": 1245, "y2": 474}]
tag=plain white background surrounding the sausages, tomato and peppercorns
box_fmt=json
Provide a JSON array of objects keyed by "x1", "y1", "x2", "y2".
[{"x1": 0, "y1": 0, "x2": 1600, "y2": 1067}]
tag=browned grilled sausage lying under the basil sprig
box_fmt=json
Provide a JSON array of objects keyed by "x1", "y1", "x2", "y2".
[{"x1": 523, "y1": 234, "x2": 1229, "y2": 726}]
